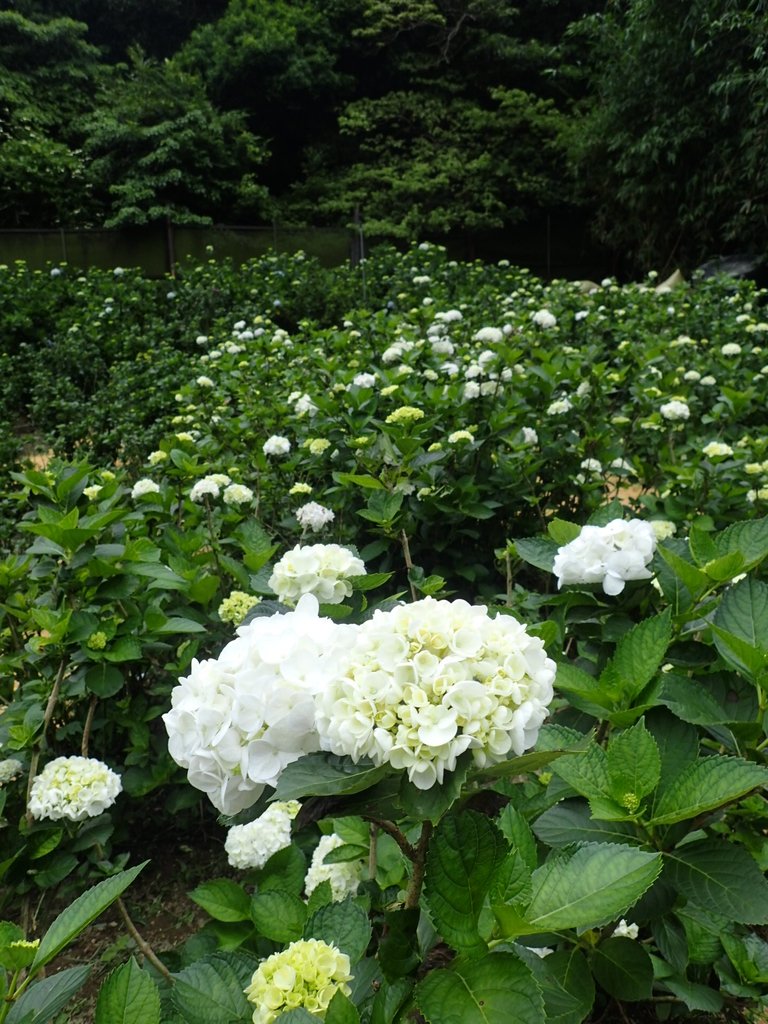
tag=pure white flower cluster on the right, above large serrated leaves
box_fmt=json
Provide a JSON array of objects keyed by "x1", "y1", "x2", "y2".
[{"x1": 552, "y1": 519, "x2": 656, "y2": 595}]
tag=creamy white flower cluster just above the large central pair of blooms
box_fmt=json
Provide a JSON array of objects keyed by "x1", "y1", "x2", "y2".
[{"x1": 269, "y1": 544, "x2": 366, "y2": 604}]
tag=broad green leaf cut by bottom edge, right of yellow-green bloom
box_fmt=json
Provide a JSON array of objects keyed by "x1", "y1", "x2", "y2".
[{"x1": 415, "y1": 952, "x2": 544, "y2": 1024}]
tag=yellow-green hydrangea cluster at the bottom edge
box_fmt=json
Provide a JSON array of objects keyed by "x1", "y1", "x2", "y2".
[{"x1": 245, "y1": 939, "x2": 352, "y2": 1024}]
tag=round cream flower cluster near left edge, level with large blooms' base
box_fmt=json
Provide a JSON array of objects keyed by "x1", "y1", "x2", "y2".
[{"x1": 28, "y1": 757, "x2": 123, "y2": 821}]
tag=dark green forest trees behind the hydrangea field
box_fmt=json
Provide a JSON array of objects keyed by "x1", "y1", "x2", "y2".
[{"x1": 0, "y1": 0, "x2": 768, "y2": 271}]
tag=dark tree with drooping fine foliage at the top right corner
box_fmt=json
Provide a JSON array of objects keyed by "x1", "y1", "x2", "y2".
[{"x1": 569, "y1": 0, "x2": 768, "y2": 270}]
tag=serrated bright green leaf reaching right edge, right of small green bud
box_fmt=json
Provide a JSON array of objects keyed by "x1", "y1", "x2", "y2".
[{"x1": 648, "y1": 755, "x2": 768, "y2": 825}]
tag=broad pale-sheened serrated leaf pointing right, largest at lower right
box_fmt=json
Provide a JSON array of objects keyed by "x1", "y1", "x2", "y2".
[{"x1": 525, "y1": 843, "x2": 662, "y2": 932}]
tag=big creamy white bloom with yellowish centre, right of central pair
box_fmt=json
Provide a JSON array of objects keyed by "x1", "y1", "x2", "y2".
[{"x1": 317, "y1": 598, "x2": 555, "y2": 790}]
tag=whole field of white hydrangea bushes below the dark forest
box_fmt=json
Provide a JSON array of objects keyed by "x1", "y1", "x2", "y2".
[{"x1": 0, "y1": 244, "x2": 768, "y2": 1024}]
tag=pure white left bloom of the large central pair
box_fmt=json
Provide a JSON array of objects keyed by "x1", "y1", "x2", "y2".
[{"x1": 163, "y1": 594, "x2": 354, "y2": 814}]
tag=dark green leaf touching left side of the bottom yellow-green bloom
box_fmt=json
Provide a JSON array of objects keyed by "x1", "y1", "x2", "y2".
[{"x1": 171, "y1": 952, "x2": 254, "y2": 1024}]
